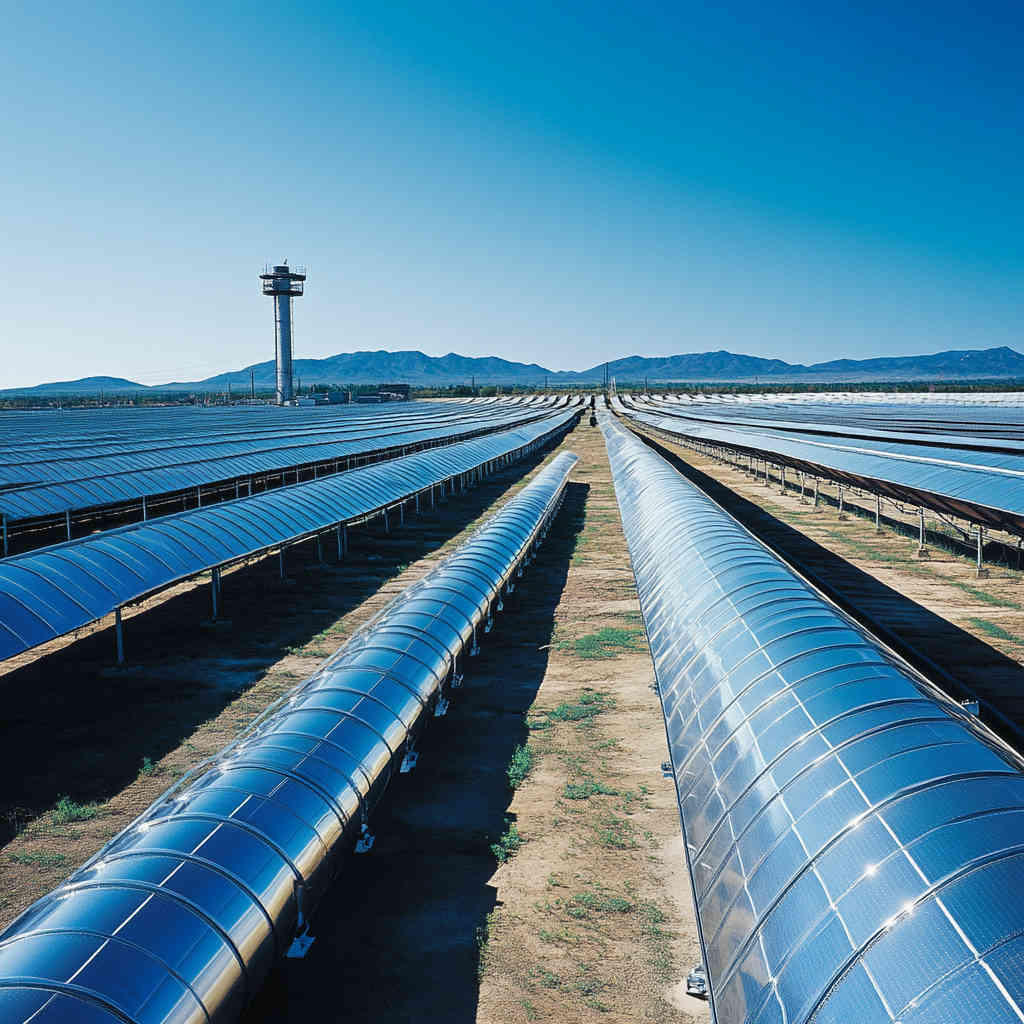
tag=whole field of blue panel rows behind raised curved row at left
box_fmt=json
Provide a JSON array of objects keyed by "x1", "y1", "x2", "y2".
[{"x1": 0, "y1": 399, "x2": 567, "y2": 551}]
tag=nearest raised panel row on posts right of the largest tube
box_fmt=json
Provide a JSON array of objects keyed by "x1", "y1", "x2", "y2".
[{"x1": 613, "y1": 398, "x2": 1024, "y2": 535}]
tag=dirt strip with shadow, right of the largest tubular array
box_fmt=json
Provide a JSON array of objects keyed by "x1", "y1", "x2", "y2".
[{"x1": 634, "y1": 428, "x2": 1024, "y2": 750}]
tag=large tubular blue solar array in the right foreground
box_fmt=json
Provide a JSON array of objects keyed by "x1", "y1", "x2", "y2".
[{"x1": 602, "y1": 414, "x2": 1024, "y2": 1024}]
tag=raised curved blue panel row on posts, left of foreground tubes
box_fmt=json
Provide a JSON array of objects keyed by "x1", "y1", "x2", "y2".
[{"x1": 0, "y1": 410, "x2": 578, "y2": 659}]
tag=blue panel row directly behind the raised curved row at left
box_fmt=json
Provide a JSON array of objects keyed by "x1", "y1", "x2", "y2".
[{"x1": 0, "y1": 397, "x2": 577, "y2": 524}]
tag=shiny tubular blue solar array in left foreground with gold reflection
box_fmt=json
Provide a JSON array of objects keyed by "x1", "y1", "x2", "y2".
[{"x1": 0, "y1": 453, "x2": 577, "y2": 1024}]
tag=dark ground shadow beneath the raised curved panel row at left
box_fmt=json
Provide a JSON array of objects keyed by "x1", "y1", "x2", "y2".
[{"x1": 0, "y1": 444, "x2": 565, "y2": 845}]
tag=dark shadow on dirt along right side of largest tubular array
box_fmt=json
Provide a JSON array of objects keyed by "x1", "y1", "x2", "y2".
[{"x1": 638, "y1": 435, "x2": 1024, "y2": 750}]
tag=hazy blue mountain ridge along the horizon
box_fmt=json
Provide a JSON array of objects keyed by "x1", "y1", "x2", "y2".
[{"x1": 6, "y1": 345, "x2": 1024, "y2": 395}]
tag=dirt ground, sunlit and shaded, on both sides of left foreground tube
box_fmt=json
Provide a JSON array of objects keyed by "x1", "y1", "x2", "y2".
[{"x1": 0, "y1": 417, "x2": 708, "y2": 1024}]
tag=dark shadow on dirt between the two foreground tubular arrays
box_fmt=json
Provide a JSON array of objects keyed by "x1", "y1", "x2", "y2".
[{"x1": 246, "y1": 483, "x2": 589, "y2": 1024}]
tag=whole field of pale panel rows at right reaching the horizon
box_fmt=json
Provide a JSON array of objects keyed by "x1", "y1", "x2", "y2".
[{"x1": 616, "y1": 397, "x2": 1024, "y2": 536}]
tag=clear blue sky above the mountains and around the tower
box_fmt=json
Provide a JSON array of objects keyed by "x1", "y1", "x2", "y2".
[{"x1": 0, "y1": 0, "x2": 1024, "y2": 387}]
